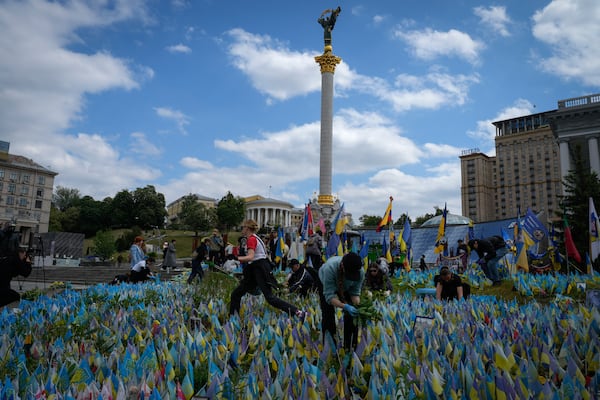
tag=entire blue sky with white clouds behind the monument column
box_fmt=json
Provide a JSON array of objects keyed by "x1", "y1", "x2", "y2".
[{"x1": 0, "y1": 0, "x2": 600, "y2": 221}]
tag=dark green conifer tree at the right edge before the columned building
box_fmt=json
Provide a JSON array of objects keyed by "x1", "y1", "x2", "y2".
[{"x1": 557, "y1": 146, "x2": 600, "y2": 261}]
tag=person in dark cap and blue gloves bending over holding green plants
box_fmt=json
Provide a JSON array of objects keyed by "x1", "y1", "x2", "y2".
[{"x1": 319, "y1": 253, "x2": 365, "y2": 350}]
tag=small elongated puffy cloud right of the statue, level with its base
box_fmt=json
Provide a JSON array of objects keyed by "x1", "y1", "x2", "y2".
[{"x1": 394, "y1": 28, "x2": 485, "y2": 64}]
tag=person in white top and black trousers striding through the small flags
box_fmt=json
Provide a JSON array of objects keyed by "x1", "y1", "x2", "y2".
[{"x1": 229, "y1": 219, "x2": 306, "y2": 319}]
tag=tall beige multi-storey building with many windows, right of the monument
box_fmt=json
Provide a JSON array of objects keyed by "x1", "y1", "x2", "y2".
[{"x1": 460, "y1": 111, "x2": 562, "y2": 222}]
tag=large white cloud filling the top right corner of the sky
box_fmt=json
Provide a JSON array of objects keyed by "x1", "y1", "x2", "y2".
[{"x1": 532, "y1": 0, "x2": 600, "y2": 87}]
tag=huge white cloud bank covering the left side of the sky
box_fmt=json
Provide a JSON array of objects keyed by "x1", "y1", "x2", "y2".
[{"x1": 0, "y1": 0, "x2": 160, "y2": 197}]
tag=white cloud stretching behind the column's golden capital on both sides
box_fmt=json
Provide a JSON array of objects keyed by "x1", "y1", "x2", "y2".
[{"x1": 229, "y1": 29, "x2": 479, "y2": 112}]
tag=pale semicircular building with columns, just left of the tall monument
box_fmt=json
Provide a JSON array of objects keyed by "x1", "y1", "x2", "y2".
[{"x1": 245, "y1": 195, "x2": 297, "y2": 228}]
